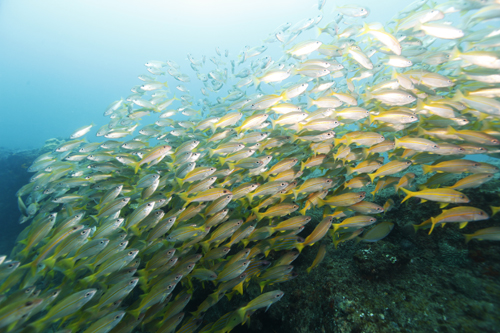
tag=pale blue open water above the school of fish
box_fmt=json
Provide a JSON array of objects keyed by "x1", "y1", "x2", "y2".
[{"x1": 0, "y1": 0, "x2": 407, "y2": 149}]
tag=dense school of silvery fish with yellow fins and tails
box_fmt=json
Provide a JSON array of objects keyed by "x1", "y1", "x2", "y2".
[{"x1": 0, "y1": 0, "x2": 500, "y2": 333}]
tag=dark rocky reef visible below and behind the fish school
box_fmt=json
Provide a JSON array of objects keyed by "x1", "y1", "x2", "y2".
[{"x1": 0, "y1": 141, "x2": 500, "y2": 333}]
